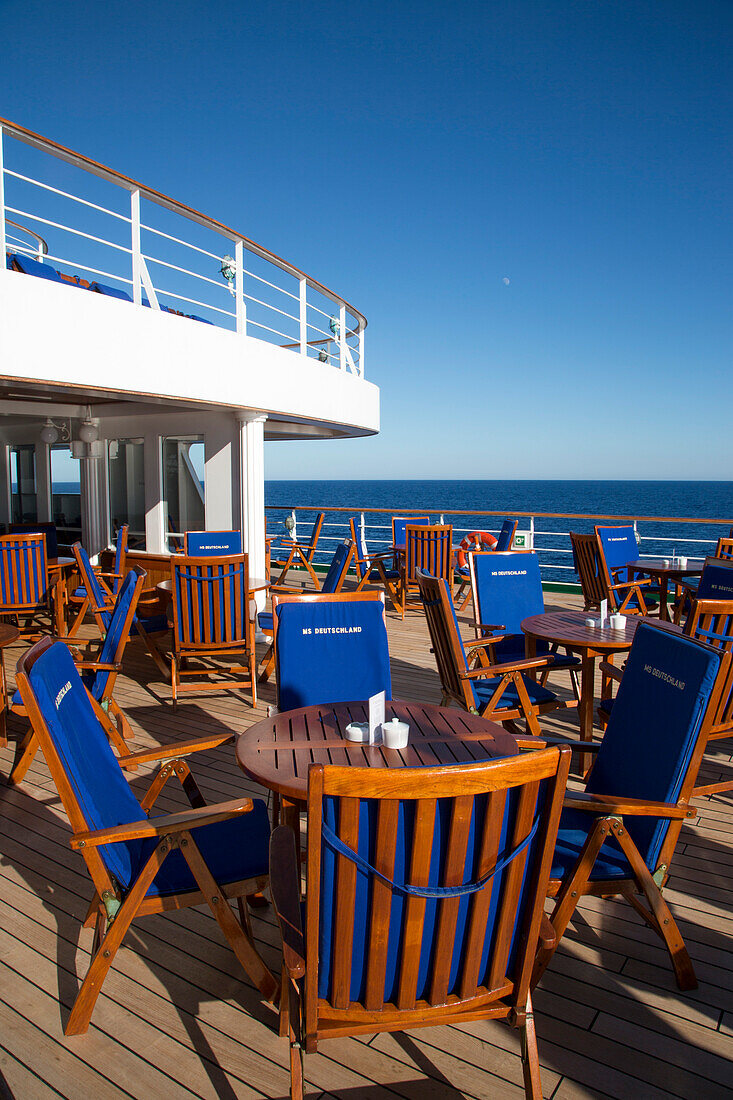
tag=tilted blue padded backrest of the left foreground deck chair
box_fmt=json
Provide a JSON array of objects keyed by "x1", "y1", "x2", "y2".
[{"x1": 15, "y1": 638, "x2": 145, "y2": 894}]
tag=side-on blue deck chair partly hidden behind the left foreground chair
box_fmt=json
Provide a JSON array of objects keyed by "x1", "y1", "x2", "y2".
[{"x1": 8, "y1": 567, "x2": 146, "y2": 783}]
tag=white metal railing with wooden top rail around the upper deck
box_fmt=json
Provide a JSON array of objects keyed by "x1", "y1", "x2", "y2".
[{"x1": 0, "y1": 119, "x2": 367, "y2": 377}]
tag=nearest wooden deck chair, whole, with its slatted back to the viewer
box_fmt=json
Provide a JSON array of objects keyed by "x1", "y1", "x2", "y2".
[{"x1": 270, "y1": 750, "x2": 570, "y2": 1100}]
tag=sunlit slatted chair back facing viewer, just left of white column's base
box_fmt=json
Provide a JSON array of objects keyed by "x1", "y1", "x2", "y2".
[{"x1": 171, "y1": 553, "x2": 251, "y2": 650}]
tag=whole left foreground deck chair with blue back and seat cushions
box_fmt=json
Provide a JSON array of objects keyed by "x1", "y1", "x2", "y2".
[{"x1": 15, "y1": 638, "x2": 278, "y2": 1035}]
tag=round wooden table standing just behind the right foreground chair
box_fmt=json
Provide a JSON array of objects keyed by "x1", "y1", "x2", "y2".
[{"x1": 522, "y1": 611, "x2": 642, "y2": 756}]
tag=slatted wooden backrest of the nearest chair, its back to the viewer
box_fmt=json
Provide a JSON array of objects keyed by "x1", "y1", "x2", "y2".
[{"x1": 306, "y1": 749, "x2": 570, "y2": 1038}]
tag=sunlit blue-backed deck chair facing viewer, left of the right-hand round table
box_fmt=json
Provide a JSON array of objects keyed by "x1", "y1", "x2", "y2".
[{"x1": 469, "y1": 550, "x2": 580, "y2": 701}]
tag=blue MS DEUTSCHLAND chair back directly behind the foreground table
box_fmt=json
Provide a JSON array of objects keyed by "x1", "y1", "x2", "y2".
[{"x1": 272, "y1": 592, "x2": 392, "y2": 711}]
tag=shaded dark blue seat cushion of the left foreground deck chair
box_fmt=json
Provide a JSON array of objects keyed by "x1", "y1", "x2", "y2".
[{"x1": 138, "y1": 799, "x2": 270, "y2": 897}]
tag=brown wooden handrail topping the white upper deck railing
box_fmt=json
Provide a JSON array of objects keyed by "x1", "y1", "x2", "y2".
[{"x1": 0, "y1": 118, "x2": 367, "y2": 331}]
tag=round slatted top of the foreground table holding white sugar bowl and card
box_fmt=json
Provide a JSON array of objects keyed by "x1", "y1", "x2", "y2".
[{"x1": 237, "y1": 700, "x2": 518, "y2": 802}]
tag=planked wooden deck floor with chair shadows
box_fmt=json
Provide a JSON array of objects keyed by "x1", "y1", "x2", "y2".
[{"x1": 0, "y1": 596, "x2": 733, "y2": 1100}]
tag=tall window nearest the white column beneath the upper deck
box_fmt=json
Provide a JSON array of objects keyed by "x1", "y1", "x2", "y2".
[{"x1": 163, "y1": 436, "x2": 206, "y2": 550}]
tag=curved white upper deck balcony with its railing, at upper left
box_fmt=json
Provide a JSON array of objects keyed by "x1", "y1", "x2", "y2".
[{"x1": 0, "y1": 120, "x2": 379, "y2": 439}]
